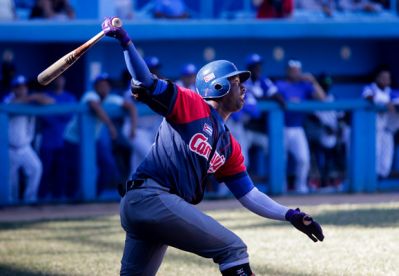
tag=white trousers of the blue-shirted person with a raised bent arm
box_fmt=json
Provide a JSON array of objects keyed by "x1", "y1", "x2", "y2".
[{"x1": 291, "y1": 127, "x2": 310, "y2": 193}]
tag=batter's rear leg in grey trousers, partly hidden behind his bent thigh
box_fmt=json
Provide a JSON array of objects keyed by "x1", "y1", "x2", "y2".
[{"x1": 120, "y1": 233, "x2": 167, "y2": 276}]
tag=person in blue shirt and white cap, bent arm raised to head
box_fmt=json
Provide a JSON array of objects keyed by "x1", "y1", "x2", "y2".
[{"x1": 276, "y1": 59, "x2": 325, "y2": 194}]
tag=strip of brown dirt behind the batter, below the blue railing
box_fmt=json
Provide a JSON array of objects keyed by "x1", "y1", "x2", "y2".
[{"x1": 0, "y1": 193, "x2": 399, "y2": 222}]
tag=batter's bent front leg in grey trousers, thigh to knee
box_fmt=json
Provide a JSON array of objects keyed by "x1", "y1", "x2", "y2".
[{"x1": 121, "y1": 181, "x2": 250, "y2": 275}]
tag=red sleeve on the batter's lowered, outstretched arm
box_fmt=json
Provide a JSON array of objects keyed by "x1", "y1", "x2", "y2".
[{"x1": 215, "y1": 134, "x2": 247, "y2": 181}]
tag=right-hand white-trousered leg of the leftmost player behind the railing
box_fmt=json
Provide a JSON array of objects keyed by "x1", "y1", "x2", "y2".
[{"x1": 21, "y1": 146, "x2": 43, "y2": 203}]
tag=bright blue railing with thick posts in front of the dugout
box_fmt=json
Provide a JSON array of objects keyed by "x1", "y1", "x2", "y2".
[{"x1": 0, "y1": 100, "x2": 388, "y2": 205}]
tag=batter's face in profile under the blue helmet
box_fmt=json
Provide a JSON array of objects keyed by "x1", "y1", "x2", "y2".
[{"x1": 222, "y1": 76, "x2": 245, "y2": 113}]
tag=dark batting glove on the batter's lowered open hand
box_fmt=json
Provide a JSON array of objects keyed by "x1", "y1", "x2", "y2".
[{"x1": 285, "y1": 208, "x2": 324, "y2": 242}]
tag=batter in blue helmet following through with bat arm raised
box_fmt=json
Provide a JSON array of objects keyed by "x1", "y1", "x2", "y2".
[{"x1": 102, "y1": 18, "x2": 324, "y2": 276}]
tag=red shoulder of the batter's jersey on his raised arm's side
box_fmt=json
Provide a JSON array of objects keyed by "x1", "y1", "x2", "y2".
[{"x1": 166, "y1": 85, "x2": 211, "y2": 124}]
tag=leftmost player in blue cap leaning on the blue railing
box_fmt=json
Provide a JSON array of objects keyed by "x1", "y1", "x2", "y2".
[{"x1": 4, "y1": 75, "x2": 54, "y2": 204}]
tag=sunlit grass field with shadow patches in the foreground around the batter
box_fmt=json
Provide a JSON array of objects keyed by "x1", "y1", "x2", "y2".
[{"x1": 0, "y1": 203, "x2": 399, "y2": 276}]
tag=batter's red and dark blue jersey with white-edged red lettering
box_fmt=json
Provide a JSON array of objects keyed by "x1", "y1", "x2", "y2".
[{"x1": 133, "y1": 83, "x2": 247, "y2": 204}]
